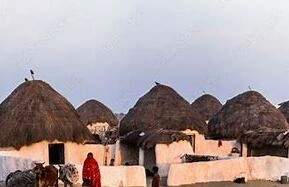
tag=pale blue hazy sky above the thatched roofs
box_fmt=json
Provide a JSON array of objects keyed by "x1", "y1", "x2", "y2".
[{"x1": 0, "y1": 0, "x2": 289, "y2": 112}]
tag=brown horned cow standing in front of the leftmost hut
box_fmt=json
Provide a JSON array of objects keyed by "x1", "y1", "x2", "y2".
[{"x1": 33, "y1": 163, "x2": 58, "y2": 187}]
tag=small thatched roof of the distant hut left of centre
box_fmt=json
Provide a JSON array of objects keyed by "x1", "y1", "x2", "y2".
[{"x1": 77, "y1": 100, "x2": 118, "y2": 127}]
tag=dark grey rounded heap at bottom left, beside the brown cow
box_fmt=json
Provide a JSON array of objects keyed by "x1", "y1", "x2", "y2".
[{"x1": 5, "y1": 170, "x2": 36, "y2": 187}]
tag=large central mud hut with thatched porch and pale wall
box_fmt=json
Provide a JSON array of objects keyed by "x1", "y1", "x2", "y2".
[{"x1": 120, "y1": 84, "x2": 207, "y2": 179}]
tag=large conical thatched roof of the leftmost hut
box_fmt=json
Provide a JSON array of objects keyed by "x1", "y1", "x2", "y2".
[{"x1": 0, "y1": 81, "x2": 90, "y2": 149}]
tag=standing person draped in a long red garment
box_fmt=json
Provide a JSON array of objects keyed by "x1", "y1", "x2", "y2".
[{"x1": 82, "y1": 153, "x2": 101, "y2": 187}]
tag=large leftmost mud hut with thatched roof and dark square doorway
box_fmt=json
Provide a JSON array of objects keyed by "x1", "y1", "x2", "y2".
[{"x1": 0, "y1": 80, "x2": 116, "y2": 164}]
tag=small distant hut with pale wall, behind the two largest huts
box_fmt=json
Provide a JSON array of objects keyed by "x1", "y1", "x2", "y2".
[{"x1": 77, "y1": 99, "x2": 118, "y2": 144}]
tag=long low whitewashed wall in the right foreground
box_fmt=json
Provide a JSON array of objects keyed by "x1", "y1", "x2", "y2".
[{"x1": 168, "y1": 156, "x2": 289, "y2": 186}]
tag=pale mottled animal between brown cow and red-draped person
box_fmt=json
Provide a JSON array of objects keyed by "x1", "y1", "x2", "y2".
[{"x1": 58, "y1": 164, "x2": 79, "y2": 187}]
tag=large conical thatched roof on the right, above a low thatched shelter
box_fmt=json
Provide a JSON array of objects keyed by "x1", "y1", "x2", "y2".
[{"x1": 208, "y1": 91, "x2": 288, "y2": 139}]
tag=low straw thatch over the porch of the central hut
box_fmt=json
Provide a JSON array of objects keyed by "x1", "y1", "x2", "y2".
[{"x1": 121, "y1": 129, "x2": 190, "y2": 149}]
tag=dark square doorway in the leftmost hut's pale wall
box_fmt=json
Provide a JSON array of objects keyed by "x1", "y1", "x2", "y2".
[{"x1": 48, "y1": 144, "x2": 65, "y2": 164}]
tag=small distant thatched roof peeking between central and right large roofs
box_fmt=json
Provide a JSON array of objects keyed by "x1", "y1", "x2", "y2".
[{"x1": 191, "y1": 94, "x2": 222, "y2": 121}]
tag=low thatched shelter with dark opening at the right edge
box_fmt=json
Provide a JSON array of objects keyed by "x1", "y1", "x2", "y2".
[{"x1": 238, "y1": 127, "x2": 289, "y2": 158}]
